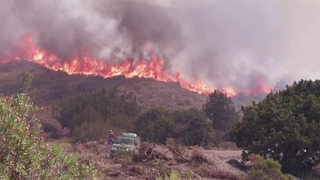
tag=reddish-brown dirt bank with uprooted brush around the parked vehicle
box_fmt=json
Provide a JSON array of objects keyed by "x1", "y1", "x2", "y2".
[{"x1": 61, "y1": 141, "x2": 246, "y2": 179}]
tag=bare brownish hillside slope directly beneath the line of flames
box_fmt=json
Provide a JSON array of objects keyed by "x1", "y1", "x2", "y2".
[{"x1": 0, "y1": 61, "x2": 206, "y2": 109}]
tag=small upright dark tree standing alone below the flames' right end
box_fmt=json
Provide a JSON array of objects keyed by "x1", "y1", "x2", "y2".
[{"x1": 204, "y1": 90, "x2": 236, "y2": 132}]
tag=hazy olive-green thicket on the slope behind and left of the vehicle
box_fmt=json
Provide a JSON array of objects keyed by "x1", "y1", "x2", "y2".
[{"x1": 59, "y1": 89, "x2": 140, "y2": 141}]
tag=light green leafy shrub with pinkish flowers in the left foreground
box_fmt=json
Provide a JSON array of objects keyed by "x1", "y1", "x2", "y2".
[{"x1": 0, "y1": 95, "x2": 95, "y2": 179}]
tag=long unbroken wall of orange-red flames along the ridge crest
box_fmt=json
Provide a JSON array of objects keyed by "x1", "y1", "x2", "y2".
[{"x1": 0, "y1": 34, "x2": 213, "y2": 94}]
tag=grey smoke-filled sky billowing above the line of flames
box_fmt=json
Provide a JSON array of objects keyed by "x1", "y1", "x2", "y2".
[{"x1": 0, "y1": 0, "x2": 320, "y2": 90}]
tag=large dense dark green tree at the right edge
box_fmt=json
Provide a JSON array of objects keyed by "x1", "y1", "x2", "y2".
[{"x1": 232, "y1": 80, "x2": 320, "y2": 172}]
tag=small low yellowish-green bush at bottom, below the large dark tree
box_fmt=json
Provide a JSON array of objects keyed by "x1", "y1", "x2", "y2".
[{"x1": 248, "y1": 156, "x2": 294, "y2": 180}]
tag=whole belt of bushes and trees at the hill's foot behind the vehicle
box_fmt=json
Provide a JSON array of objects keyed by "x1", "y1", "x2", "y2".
[{"x1": 60, "y1": 89, "x2": 240, "y2": 146}]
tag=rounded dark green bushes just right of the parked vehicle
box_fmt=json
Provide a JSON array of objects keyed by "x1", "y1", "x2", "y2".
[{"x1": 136, "y1": 108, "x2": 213, "y2": 145}]
